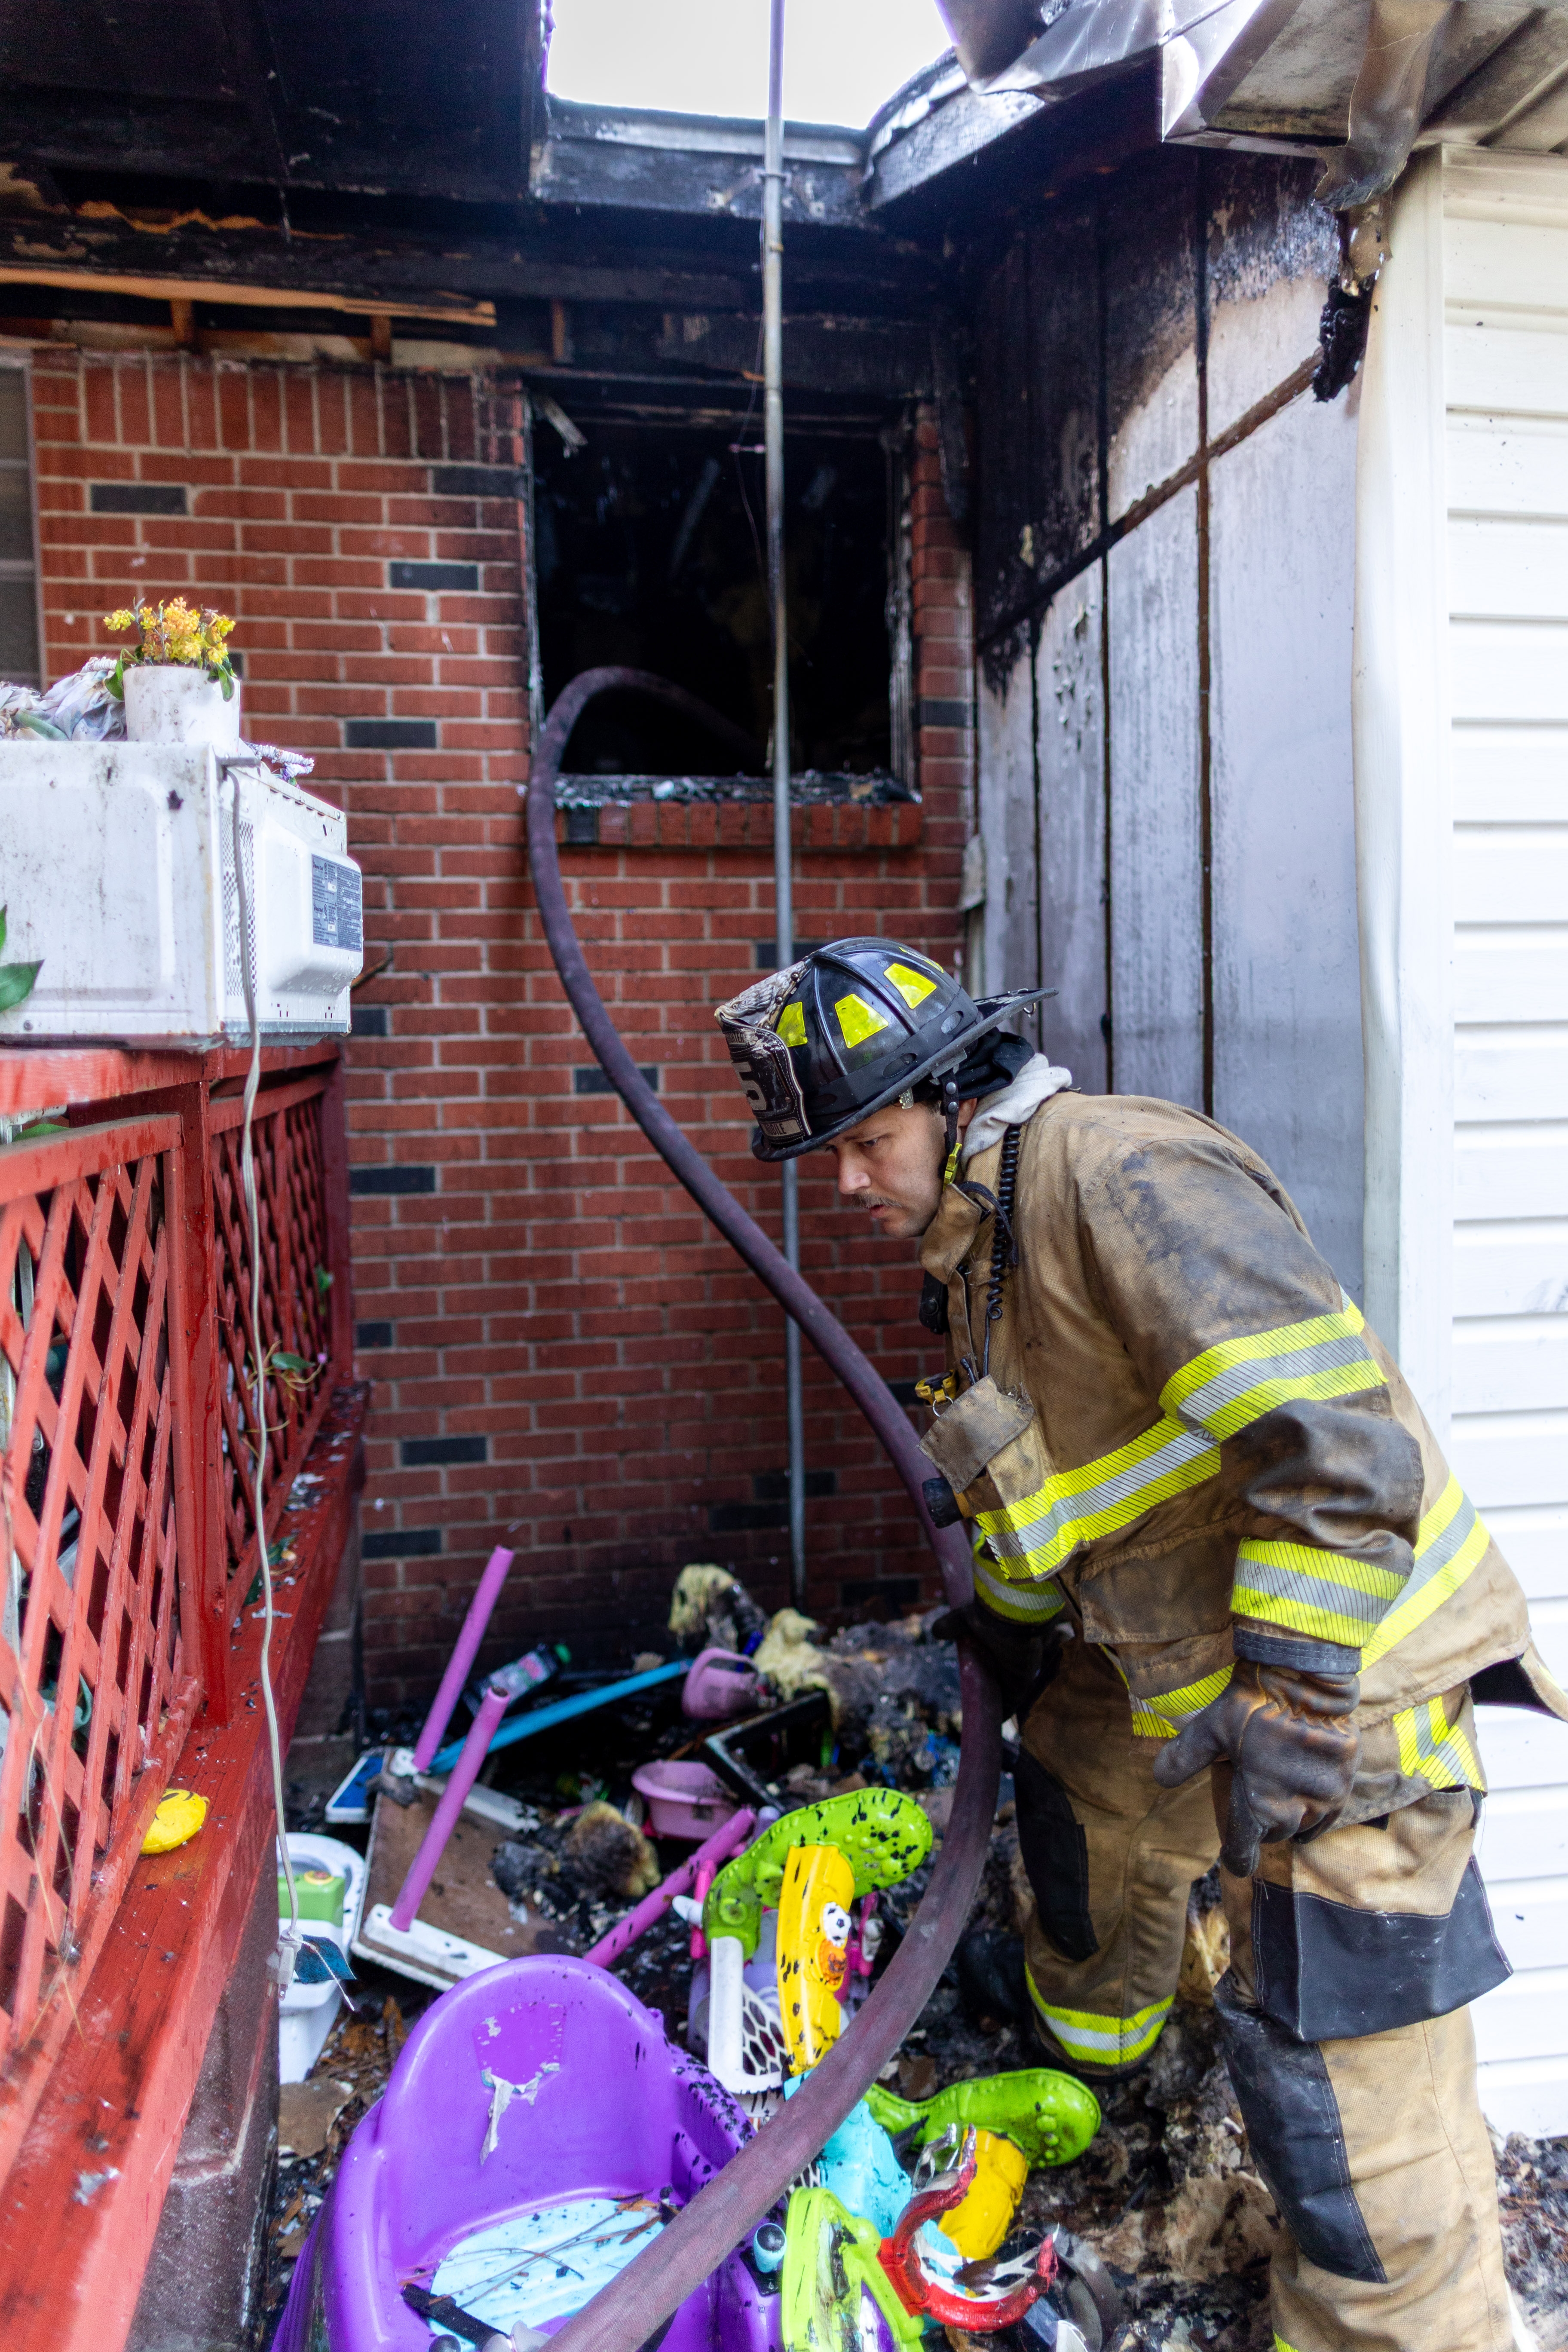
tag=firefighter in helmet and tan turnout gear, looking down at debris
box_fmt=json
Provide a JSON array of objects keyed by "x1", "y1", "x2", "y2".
[{"x1": 717, "y1": 938, "x2": 1568, "y2": 2352}]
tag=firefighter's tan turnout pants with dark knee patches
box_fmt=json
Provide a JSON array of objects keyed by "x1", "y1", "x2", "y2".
[{"x1": 1018, "y1": 1642, "x2": 1514, "y2": 2352}]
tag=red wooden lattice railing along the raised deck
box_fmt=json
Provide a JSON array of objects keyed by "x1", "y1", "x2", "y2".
[{"x1": 0, "y1": 1056, "x2": 348, "y2": 2060}]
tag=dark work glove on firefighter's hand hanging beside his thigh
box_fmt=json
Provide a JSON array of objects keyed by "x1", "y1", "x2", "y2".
[{"x1": 1154, "y1": 1642, "x2": 1361, "y2": 1879}]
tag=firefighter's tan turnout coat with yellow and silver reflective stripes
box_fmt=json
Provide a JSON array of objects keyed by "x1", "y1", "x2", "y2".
[{"x1": 922, "y1": 1091, "x2": 1568, "y2": 1818}]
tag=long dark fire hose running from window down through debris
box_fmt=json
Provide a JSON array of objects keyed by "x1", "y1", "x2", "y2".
[{"x1": 527, "y1": 668, "x2": 1001, "y2": 2352}]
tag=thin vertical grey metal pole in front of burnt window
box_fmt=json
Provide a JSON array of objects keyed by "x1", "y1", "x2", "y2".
[{"x1": 762, "y1": 0, "x2": 806, "y2": 1609}]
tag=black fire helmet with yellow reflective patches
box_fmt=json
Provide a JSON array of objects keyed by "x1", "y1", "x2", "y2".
[{"x1": 715, "y1": 938, "x2": 1056, "y2": 1160}]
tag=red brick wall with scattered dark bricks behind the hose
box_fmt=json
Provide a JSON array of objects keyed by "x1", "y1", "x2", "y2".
[{"x1": 35, "y1": 353, "x2": 971, "y2": 1700}]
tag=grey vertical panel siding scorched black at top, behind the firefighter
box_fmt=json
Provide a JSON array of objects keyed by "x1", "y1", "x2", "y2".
[{"x1": 976, "y1": 150, "x2": 1361, "y2": 1286}]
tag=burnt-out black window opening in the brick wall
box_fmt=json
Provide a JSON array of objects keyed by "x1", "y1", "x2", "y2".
[{"x1": 534, "y1": 419, "x2": 891, "y2": 776}]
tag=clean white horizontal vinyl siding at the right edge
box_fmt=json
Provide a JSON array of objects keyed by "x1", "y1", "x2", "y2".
[{"x1": 1441, "y1": 150, "x2": 1568, "y2": 2133}]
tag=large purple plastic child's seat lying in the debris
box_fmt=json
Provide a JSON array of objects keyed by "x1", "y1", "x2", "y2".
[{"x1": 275, "y1": 1957, "x2": 778, "y2": 2352}]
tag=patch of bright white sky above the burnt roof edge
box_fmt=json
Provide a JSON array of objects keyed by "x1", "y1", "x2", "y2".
[{"x1": 550, "y1": 0, "x2": 950, "y2": 129}]
